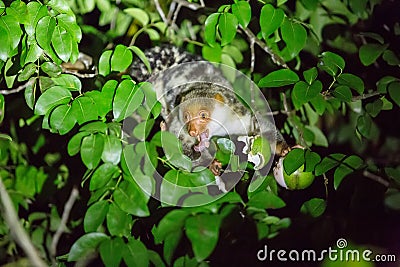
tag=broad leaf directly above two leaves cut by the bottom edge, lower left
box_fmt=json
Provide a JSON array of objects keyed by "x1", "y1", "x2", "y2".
[{"x1": 106, "y1": 202, "x2": 133, "y2": 236}]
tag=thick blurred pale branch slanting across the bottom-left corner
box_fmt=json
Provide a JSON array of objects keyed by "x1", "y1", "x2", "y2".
[{"x1": 0, "y1": 177, "x2": 48, "y2": 267}]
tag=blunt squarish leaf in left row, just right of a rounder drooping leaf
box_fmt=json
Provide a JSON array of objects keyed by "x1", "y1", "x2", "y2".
[{"x1": 72, "y1": 96, "x2": 98, "y2": 125}]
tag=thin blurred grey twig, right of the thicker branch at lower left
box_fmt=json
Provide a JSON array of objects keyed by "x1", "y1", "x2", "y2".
[{"x1": 50, "y1": 187, "x2": 79, "y2": 263}]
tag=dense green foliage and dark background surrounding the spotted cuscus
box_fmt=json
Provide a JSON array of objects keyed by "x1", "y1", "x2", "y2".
[{"x1": 0, "y1": 0, "x2": 400, "y2": 266}]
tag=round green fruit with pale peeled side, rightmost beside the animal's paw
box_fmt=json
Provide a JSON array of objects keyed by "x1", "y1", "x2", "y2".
[{"x1": 274, "y1": 157, "x2": 315, "y2": 190}]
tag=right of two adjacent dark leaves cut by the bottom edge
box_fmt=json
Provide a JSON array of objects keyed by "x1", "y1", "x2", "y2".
[{"x1": 123, "y1": 238, "x2": 149, "y2": 267}]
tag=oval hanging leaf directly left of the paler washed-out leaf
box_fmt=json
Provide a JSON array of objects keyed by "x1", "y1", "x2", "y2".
[{"x1": 81, "y1": 134, "x2": 104, "y2": 169}]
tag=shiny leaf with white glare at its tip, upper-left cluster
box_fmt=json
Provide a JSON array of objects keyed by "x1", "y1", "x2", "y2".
[{"x1": 51, "y1": 25, "x2": 72, "y2": 62}]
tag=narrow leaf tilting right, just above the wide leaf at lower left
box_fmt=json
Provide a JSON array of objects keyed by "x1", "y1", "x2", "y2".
[{"x1": 83, "y1": 200, "x2": 109, "y2": 233}]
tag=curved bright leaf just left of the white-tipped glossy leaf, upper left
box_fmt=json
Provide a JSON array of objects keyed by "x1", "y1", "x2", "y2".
[{"x1": 36, "y1": 16, "x2": 56, "y2": 59}]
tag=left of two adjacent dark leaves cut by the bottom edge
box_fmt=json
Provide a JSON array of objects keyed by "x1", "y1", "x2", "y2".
[{"x1": 100, "y1": 237, "x2": 126, "y2": 267}]
